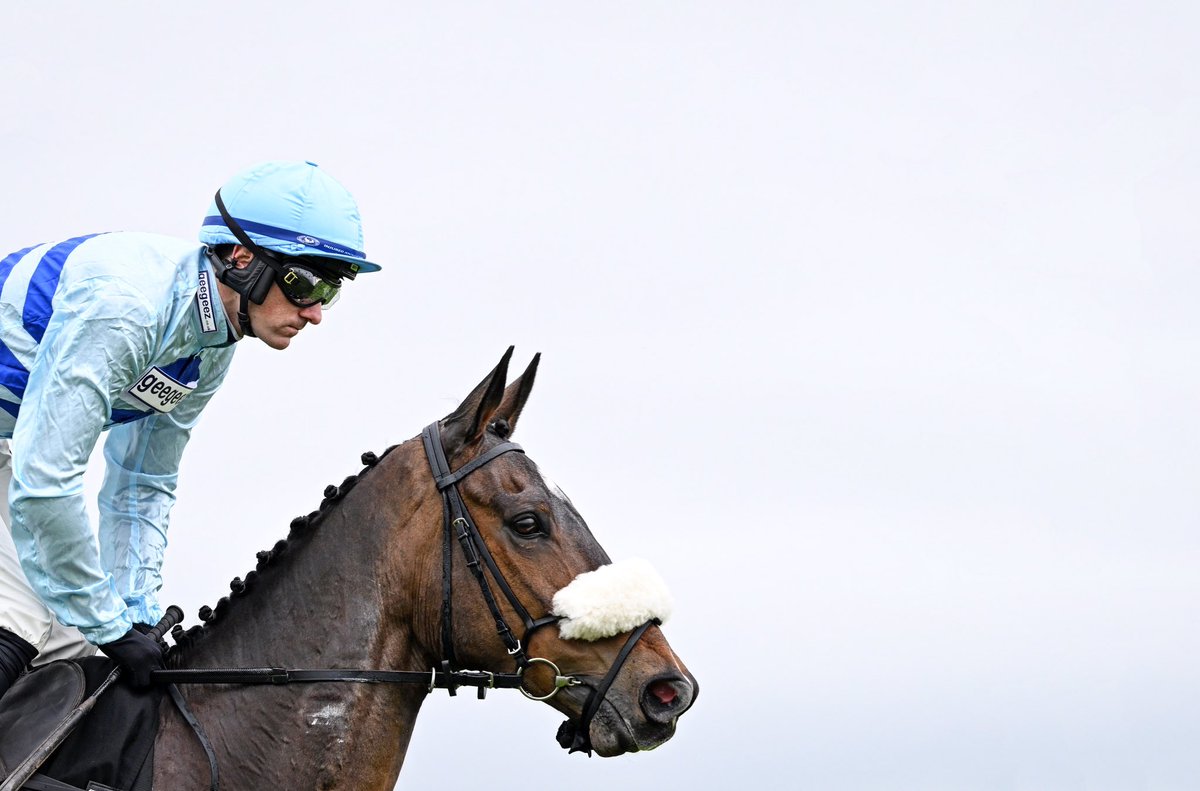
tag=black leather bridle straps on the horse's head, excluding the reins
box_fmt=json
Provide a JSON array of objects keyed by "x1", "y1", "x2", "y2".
[{"x1": 421, "y1": 423, "x2": 658, "y2": 755}]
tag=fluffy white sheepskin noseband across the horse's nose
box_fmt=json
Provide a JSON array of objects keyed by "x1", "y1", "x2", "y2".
[{"x1": 553, "y1": 558, "x2": 673, "y2": 640}]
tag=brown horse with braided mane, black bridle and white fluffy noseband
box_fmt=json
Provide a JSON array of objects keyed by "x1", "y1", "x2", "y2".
[{"x1": 140, "y1": 347, "x2": 698, "y2": 791}]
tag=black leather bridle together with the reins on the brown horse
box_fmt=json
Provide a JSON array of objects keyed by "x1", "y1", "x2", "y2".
[{"x1": 151, "y1": 423, "x2": 659, "y2": 791}]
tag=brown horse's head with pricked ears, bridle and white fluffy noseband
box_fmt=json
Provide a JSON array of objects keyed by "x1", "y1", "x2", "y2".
[{"x1": 385, "y1": 348, "x2": 697, "y2": 756}]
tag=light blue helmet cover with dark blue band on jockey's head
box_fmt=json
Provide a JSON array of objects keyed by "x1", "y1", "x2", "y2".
[{"x1": 200, "y1": 161, "x2": 379, "y2": 272}]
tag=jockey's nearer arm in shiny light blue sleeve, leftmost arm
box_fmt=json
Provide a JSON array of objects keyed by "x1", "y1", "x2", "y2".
[{"x1": 10, "y1": 277, "x2": 157, "y2": 645}]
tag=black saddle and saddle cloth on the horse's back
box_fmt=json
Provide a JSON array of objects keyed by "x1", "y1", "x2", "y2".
[{"x1": 0, "y1": 657, "x2": 163, "y2": 791}]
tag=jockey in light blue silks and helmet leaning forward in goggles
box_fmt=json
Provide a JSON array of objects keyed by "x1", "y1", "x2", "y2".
[{"x1": 0, "y1": 162, "x2": 379, "y2": 695}]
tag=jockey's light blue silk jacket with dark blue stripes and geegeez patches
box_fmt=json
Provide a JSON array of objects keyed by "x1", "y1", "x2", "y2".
[{"x1": 0, "y1": 233, "x2": 234, "y2": 645}]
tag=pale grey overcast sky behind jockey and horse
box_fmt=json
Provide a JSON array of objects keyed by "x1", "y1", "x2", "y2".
[{"x1": 0, "y1": 2, "x2": 1200, "y2": 791}]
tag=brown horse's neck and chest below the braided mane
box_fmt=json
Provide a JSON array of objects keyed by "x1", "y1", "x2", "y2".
[{"x1": 162, "y1": 458, "x2": 440, "y2": 789}]
